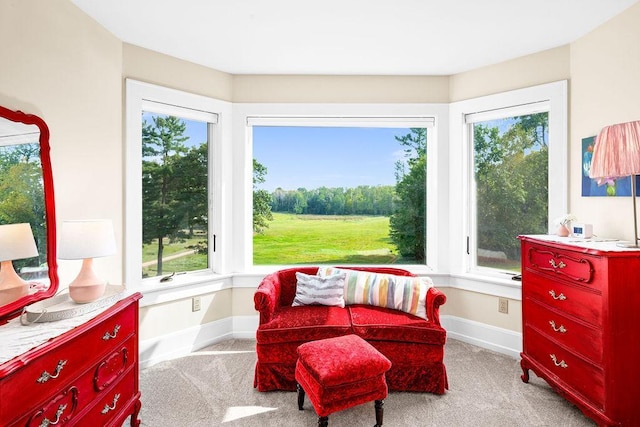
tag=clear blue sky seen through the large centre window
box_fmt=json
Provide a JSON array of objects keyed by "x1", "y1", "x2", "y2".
[{"x1": 253, "y1": 126, "x2": 410, "y2": 191}]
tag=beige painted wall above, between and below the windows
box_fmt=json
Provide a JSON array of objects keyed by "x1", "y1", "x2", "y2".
[{"x1": 0, "y1": 0, "x2": 640, "y2": 339}]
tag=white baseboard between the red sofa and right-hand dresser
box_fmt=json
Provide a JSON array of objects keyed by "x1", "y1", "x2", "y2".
[{"x1": 440, "y1": 315, "x2": 522, "y2": 359}]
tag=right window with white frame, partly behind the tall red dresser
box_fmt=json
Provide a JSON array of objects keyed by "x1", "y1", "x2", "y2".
[{"x1": 449, "y1": 81, "x2": 568, "y2": 278}]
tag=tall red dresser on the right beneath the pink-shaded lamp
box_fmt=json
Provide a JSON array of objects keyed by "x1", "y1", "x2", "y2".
[{"x1": 520, "y1": 236, "x2": 640, "y2": 426}]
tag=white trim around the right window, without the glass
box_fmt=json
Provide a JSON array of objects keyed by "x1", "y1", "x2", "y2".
[{"x1": 449, "y1": 81, "x2": 568, "y2": 294}]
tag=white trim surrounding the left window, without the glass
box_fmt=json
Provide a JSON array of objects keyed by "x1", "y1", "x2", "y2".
[{"x1": 123, "y1": 79, "x2": 231, "y2": 293}]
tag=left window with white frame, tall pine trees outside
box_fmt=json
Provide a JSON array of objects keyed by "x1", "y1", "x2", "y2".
[{"x1": 125, "y1": 80, "x2": 228, "y2": 284}]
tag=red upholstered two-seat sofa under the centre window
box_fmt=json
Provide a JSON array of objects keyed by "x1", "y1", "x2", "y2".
[{"x1": 254, "y1": 267, "x2": 448, "y2": 394}]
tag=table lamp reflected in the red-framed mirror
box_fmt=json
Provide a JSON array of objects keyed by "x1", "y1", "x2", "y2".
[{"x1": 0, "y1": 223, "x2": 38, "y2": 305}]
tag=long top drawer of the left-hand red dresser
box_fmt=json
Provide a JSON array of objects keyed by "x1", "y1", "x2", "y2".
[{"x1": 0, "y1": 305, "x2": 135, "y2": 423}]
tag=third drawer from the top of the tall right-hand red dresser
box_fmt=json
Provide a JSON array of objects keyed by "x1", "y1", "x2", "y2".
[{"x1": 523, "y1": 298, "x2": 602, "y2": 365}]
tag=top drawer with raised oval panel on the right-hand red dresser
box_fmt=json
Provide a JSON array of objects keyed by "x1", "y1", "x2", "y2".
[{"x1": 523, "y1": 245, "x2": 604, "y2": 290}]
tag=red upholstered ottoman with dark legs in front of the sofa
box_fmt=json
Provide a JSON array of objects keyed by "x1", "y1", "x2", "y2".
[{"x1": 295, "y1": 335, "x2": 391, "y2": 427}]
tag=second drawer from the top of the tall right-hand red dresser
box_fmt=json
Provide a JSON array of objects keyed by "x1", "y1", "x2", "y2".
[{"x1": 522, "y1": 272, "x2": 602, "y2": 327}]
